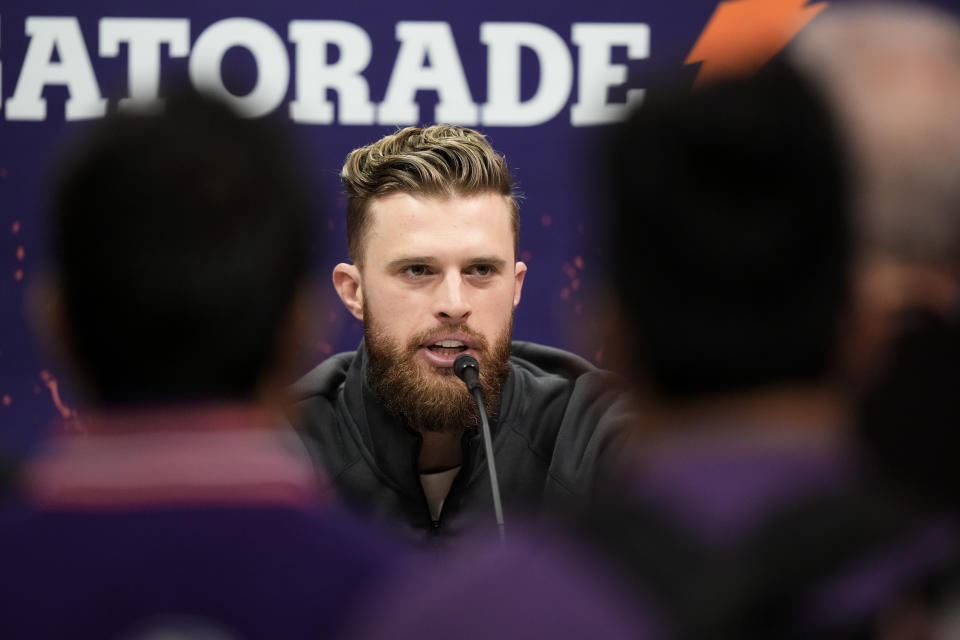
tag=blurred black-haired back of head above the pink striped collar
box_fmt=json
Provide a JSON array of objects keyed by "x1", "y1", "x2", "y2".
[{"x1": 45, "y1": 93, "x2": 311, "y2": 405}]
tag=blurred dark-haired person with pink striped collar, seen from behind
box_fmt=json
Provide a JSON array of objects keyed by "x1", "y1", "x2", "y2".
[{"x1": 0, "y1": 93, "x2": 399, "y2": 639}]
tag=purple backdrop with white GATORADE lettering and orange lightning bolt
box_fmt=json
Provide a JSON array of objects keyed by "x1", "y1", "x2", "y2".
[{"x1": 0, "y1": 0, "x2": 960, "y2": 454}]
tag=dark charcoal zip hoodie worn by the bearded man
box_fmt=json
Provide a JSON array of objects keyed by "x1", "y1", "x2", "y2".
[{"x1": 293, "y1": 341, "x2": 634, "y2": 540}]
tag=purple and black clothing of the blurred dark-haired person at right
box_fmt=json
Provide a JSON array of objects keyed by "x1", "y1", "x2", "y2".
[{"x1": 579, "y1": 441, "x2": 960, "y2": 638}]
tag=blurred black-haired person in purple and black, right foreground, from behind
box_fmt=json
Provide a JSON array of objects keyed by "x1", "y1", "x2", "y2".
[{"x1": 585, "y1": 60, "x2": 955, "y2": 638}]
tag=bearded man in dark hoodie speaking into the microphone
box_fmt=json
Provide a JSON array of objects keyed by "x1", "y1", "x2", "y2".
[{"x1": 294, "y1": 125, "x2": 628, "y2": 539}]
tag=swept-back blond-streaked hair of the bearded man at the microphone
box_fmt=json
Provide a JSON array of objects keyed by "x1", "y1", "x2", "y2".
[{"x1": 340, "y1": 124, "x2": 520, "y2": 264}]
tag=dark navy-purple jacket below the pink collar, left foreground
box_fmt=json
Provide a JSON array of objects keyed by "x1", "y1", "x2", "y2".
[{"x1": 0, "y1": 456, "x2": 406, "y2": 638}]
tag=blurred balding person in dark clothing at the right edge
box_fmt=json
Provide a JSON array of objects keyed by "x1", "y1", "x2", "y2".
[{"x1": 790, "y1": 3, "x2": 960, "y2": 508}]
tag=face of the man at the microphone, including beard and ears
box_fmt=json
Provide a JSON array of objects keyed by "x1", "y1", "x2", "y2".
[{"x1": 334, "y1": 193, "x2": 526, "y2": 430}]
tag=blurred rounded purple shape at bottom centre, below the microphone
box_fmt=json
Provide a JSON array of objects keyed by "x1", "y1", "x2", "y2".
[{"x1": 349, "y1": 521, "x2": 662, "y2": 640}]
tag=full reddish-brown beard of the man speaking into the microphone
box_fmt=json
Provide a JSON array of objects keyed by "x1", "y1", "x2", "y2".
[{"x1": 363, "y1": 308, "x2": 513, "y2": 433}]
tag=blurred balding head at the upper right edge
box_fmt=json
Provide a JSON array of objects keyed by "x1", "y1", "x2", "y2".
[{"x1": 789, "y1": 3, "x2": 960, "y2": 330}]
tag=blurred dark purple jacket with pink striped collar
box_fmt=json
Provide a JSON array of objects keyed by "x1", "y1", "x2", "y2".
[{"x1": 0, "y1": 406, "x2": 398, "y2": 640}]
